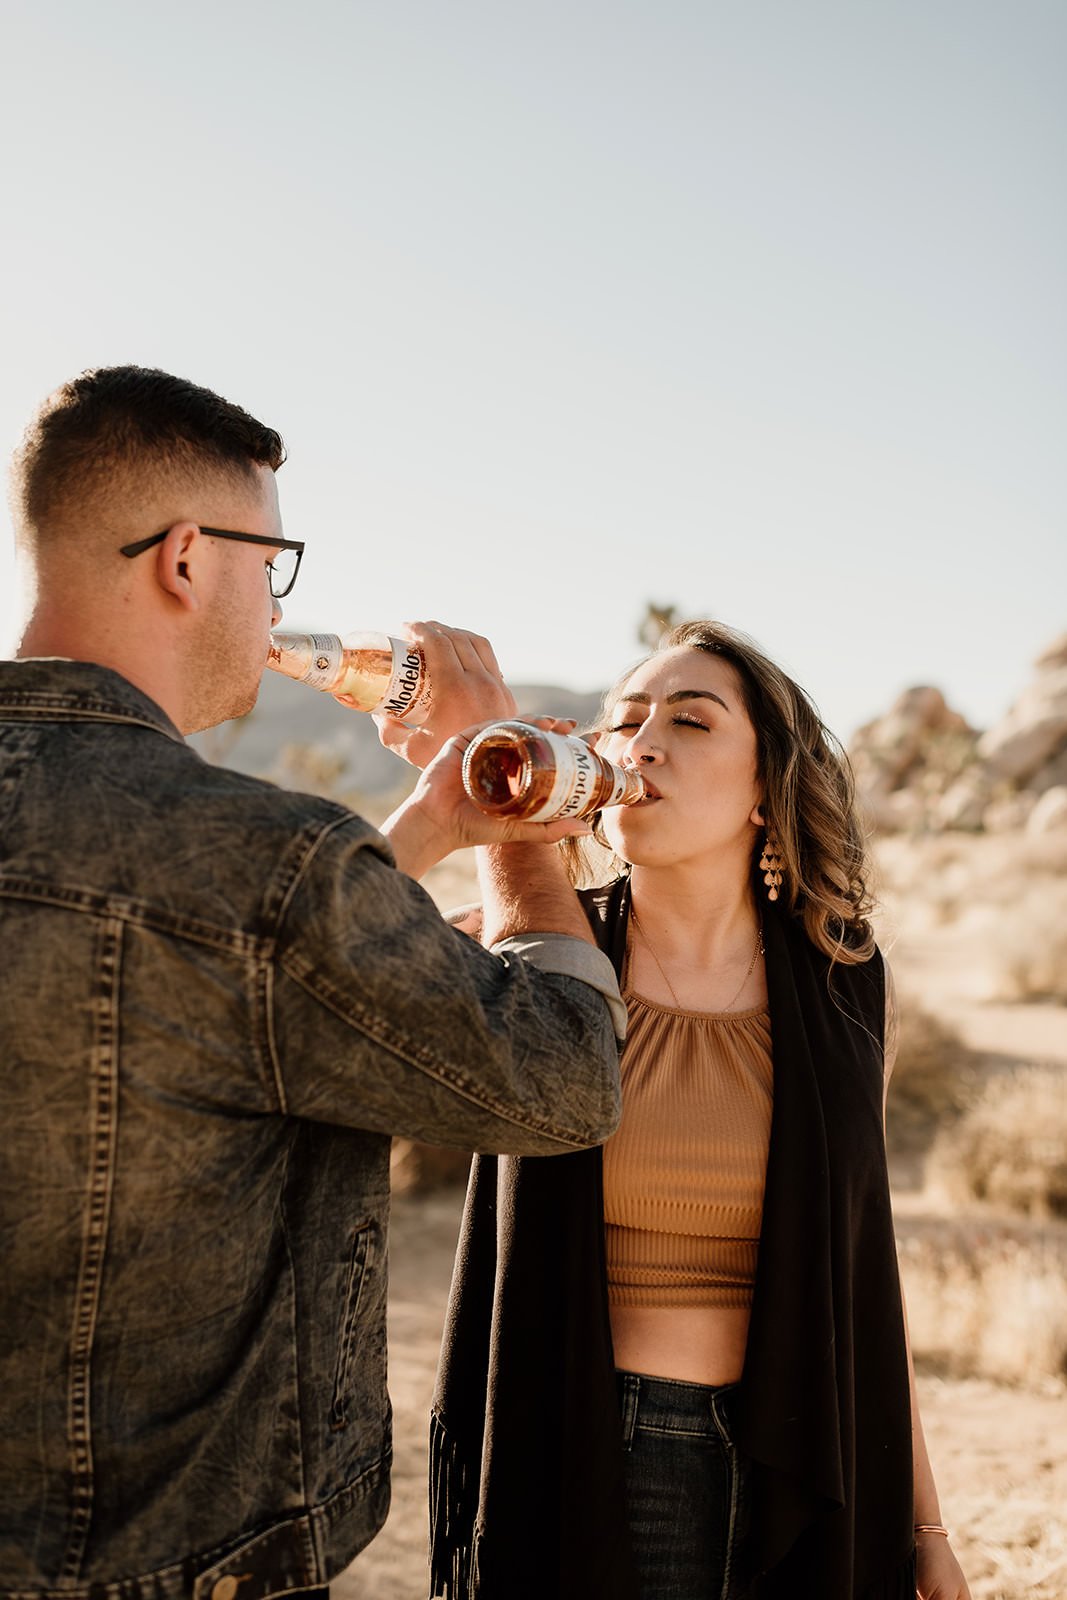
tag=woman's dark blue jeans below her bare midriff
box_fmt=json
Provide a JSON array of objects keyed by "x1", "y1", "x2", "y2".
[{"x1": 616, "y1": 1373, "x2": 745, "y2": 1600}]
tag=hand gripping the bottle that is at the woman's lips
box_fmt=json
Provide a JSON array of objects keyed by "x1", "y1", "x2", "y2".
[{"x1": 381, "y1": 717, "x2": 590, "y2": 878}]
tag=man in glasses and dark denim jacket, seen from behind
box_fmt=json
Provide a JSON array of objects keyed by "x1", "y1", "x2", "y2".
[{"x1": 0, "y1": 368, "x2": 617, "y2": 1600}]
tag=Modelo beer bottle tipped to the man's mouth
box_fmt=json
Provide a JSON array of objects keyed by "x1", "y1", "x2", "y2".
[{"x1": 267, "y1": 634, "x2": 430, "y2": 723}]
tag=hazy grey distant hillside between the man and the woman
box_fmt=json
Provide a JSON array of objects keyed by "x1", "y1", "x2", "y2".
[{"x1": 190, "y1": 672, "x2": 600, "y2": 795}]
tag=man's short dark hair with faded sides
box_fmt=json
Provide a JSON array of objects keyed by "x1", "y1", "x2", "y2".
[{"x1": 13, "y1": 366, "x2": 285, "y2": 533}]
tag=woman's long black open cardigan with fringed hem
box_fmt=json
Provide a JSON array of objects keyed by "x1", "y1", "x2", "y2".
[{"x1": 430, "y1": 878, "x2": 915, "y2": 1600}]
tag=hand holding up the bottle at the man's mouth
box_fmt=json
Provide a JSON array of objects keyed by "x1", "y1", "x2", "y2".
[{"x1": 367, "y1": 622, "x2": 515, "y2": 768}]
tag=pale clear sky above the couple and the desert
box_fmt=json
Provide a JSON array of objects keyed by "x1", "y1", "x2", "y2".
[{"x1": 0, "y1": 0, "x2": 1067, "y2": 734}]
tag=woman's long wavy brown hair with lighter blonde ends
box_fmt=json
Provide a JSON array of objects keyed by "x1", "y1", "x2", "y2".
[{"x1": 563, "y1": 621, "x2": 875, "y2": 965}]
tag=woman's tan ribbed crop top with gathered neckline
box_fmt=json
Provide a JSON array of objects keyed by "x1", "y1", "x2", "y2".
[{"x1": 603, "y1": 992, "x2": 773, "y2": 1307}]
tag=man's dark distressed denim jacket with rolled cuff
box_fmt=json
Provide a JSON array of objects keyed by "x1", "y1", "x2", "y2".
[{"x1": 0, "y1": 661, "x2": 619, "y2": 1600}]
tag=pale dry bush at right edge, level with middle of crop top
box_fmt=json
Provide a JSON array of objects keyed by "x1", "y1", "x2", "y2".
[{"x1": 928, "y1": 1066, "x2": 1067, "y2": 1218}]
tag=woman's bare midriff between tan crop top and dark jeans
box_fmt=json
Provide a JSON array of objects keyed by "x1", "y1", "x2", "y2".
[{"x1": 611, "y1": 1306, "x2": 749, "y2": 1384}]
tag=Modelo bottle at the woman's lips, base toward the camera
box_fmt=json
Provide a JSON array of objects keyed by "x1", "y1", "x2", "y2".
[{"x1": 462, "y1": 722, "x2": 645, "y2": 822}]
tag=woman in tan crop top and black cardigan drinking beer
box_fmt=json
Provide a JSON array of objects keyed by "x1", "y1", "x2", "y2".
[{"x1": 430, "y1": 622, "x2": 968, "y2": 1600}]
